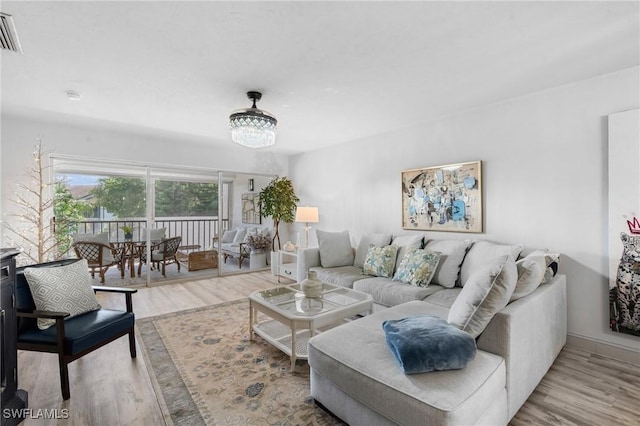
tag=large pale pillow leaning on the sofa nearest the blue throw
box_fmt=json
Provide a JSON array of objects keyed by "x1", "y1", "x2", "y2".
[{"x1": 447, "y1": 255, "x2": 518, "y2": 338}]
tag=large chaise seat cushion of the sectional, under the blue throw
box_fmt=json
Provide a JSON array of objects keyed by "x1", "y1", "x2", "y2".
[{"x1": 308, "y1": 300, "x2": 506, "y2": 425}]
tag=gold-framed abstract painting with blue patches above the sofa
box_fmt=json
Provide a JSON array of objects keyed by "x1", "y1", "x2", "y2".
[{"x1": 402, "y1": 160, "x2": 484, "y2": 233}]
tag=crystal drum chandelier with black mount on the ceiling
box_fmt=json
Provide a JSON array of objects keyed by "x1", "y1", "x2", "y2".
[{"x1": 229, "y1": 92, "x2": 278, "y2": 148}]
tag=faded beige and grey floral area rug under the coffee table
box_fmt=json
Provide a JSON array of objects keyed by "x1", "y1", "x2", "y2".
[{"x1": 136, "y1": 299, "x2": 342, "y2": 425}]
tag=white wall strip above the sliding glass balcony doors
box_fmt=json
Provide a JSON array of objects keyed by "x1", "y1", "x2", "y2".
[{"x1": 0, "y1": 115, "x2": 288, "y2": 216}]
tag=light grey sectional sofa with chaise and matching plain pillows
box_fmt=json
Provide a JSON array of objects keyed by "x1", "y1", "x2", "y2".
[{"x1": 298, "y1": 234, "x2": 566, "y2": 425}]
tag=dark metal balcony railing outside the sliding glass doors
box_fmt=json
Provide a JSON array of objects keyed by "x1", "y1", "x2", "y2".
[{"x1": 72, "y1": 217, "x2": 229, "y2": 249}]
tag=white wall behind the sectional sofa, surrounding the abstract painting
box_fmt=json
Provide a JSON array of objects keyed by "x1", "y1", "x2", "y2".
[{"x1": 289, "y1": 67, "x2": 640, "y2": 351}]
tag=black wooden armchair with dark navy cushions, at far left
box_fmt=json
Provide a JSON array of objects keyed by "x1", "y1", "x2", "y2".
[{"x1": 15, "y1": 259, "x2": 137, "y2": 402}]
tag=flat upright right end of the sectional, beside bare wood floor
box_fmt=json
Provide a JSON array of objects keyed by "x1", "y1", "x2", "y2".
[{"x1": 477, "y1": 275, "x2": 567, "y2": 419}]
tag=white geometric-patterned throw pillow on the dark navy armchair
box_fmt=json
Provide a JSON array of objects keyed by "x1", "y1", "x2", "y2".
[{"x1": 24, "y1": 259, "x2": 101, "y2": 330}]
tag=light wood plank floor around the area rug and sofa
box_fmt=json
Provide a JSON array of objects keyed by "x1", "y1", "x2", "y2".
[{"x1": 18, "y1": 271, "x2": 640, "y2": 426}]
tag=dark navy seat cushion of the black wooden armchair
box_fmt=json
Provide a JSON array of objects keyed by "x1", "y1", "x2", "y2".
[{"x1": 18, "y1": 309, "x2": 135, "y2": 355}]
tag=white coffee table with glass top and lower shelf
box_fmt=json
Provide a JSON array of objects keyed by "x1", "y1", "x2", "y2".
[{"x1": 249, "y1": 283, "x2": 373, "y2": 370}]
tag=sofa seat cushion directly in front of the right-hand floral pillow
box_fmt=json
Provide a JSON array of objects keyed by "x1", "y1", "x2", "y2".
[{"x1": 353, "y1": 277, "x2": 443, "y2": 306}]
